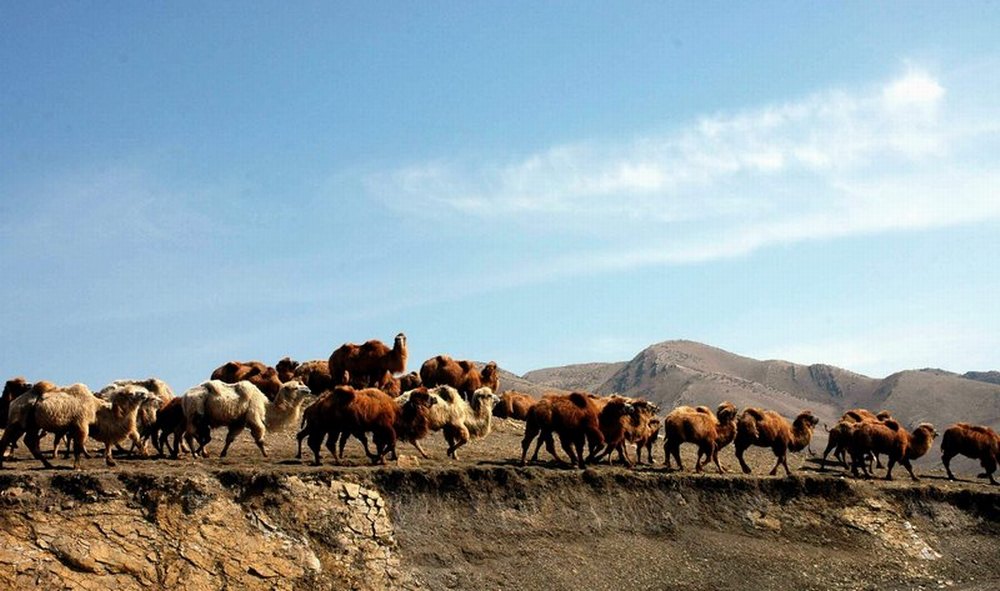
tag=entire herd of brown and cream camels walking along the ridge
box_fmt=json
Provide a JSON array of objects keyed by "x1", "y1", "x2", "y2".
[{"x1": 0, "y1": 333, "x2": 1000, "y2": 484}]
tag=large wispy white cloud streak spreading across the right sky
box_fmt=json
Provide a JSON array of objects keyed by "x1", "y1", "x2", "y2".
[{"x1": 364, "y1": 66, "x2": 1000, "y2": 273}]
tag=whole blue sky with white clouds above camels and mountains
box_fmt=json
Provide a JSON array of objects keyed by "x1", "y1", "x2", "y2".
[{"x1": 0, "y1": 2, "x2": 1000, "y2": 390}]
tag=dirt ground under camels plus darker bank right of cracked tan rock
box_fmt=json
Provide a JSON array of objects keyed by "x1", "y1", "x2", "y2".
[{"x1": 0, "y1": 421, "x2": 1000, "y2": 590}]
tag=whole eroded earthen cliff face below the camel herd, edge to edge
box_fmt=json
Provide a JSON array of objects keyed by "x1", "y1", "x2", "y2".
[{"x1": 0, "y1": 465, "x2": 1000, "y2": 590}]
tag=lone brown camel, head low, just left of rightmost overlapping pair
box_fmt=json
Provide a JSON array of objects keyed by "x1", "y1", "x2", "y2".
[{"x1": 735, "y1": 408, "x2": 819, "y2": 476}]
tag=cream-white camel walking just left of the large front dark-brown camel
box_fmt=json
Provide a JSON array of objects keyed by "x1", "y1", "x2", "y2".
[{"x1": 180, "y1": 380, "x2": 310, "y2": 457}]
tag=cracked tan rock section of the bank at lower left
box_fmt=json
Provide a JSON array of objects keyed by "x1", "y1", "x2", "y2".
[{"x1": 0, "y1": 473, "x2": 413, "y2": 589}]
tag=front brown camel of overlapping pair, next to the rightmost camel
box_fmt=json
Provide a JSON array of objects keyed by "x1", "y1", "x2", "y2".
[{"x1": 850, "y1": 419, "x2": 937, "y2": 480}]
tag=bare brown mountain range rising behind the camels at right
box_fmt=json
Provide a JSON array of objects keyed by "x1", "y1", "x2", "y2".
[{"x1": 501, "y1": 341, "x2": 1000, "y2": 438}]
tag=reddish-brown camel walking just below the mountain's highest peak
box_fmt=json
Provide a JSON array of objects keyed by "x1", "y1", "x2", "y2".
[{"x1": 663, "y1": 402, "x2": 736, "y2": 474}]
